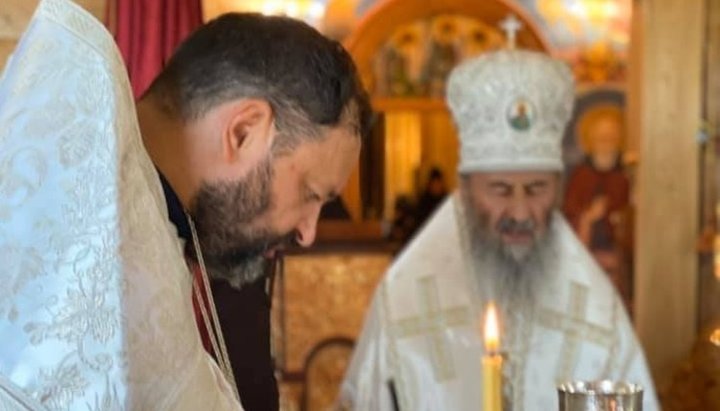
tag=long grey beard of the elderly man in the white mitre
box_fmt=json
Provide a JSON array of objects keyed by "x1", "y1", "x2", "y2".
[{"x1": 464, "y1": 196, "x2": 555, "y2": 308}]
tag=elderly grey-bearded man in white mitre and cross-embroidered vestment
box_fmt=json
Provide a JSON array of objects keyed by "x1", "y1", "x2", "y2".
[{"x1": 341, "y1": 50, "x2": 658, "y2": 411}]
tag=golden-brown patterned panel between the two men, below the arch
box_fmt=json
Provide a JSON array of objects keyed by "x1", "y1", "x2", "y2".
[{"x1": 273, "y1": 251, "x2": 392, "y2": 372}]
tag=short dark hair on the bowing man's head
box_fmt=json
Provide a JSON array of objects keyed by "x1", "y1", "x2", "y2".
[{"x1": 143, "y1": 13, "x2": 371, "y2": 149}]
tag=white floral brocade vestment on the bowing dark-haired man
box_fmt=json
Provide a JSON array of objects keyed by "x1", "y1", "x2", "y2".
[{"x1": 0, "y1": 0, "x2": 242, "y2": 411}]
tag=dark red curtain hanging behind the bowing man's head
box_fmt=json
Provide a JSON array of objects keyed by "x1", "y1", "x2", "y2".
[{"x1": 107, "y1": 0, "x2": 202, "y2": 98}]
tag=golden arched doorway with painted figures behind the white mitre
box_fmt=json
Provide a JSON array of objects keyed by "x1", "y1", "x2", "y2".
[{"x1": 345, "y1": 0, "x2": 551, "y2": 220}]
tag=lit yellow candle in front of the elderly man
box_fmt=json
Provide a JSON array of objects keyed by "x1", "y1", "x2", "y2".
[{"x1": 482, "y1": 302, "x2": 503, "y2": 411}]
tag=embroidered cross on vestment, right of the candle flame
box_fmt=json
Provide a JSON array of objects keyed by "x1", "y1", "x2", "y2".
[{"x1": 538, "y1": 283, "x2": 614, "y2": 379}]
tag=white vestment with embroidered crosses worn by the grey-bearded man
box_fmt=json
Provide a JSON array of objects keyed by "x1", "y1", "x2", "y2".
[{"x1": 340, "y1": 195, "x2": 659, "y2": 411}]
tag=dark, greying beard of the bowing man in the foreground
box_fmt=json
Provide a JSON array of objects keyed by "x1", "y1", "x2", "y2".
[{"x1": 191, "y1": 158, "x2": 292, "y2": 288}]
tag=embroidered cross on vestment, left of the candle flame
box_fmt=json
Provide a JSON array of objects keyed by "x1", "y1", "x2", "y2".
[{"x1": 393, "y1": 277, "x2": 471, "y2": 381}]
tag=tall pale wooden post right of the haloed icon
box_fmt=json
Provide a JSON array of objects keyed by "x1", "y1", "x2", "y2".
[{"x1": 635, "y1": 0, "x2": 705, "y2": 383}]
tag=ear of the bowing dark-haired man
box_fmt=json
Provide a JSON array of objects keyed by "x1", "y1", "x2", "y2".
[{"x1": 222, "y1": 99, "x2": 275, "y2": 163}]
